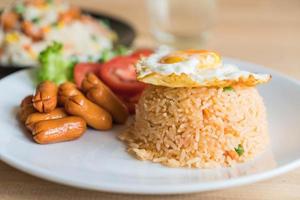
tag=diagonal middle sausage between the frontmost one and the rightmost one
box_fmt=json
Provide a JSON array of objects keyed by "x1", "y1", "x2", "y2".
[{"x1": 65, "y1": 95, "x2": 112, "y2": 130}]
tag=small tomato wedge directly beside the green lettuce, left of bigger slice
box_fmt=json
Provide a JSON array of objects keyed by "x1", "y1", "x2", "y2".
[{"x1": 74, "y1": 63, "x2": 102, "y2": 88}]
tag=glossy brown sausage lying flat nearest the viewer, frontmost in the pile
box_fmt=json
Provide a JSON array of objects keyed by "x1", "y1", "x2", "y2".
[{"x1": 32, "y1": 117, "x2": 86, "y2": 144}]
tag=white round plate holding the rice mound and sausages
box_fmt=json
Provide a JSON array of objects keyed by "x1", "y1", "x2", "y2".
[{"x1": 0, "y1": 59, "x2": 300, "y2": 194}]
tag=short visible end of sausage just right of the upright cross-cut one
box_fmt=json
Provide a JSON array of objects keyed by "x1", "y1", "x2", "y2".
[{"x1": 58, "y1": 82, "x2": 83, "y2": 106}]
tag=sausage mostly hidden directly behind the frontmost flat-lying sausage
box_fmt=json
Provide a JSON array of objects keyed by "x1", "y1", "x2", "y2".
[{"x1": 25, "y1": 108, "x2": 67, "y2": 130}]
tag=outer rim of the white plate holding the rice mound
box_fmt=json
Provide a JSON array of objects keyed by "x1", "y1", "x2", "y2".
[{"x1": 0, "y1": 57, "x2": 300, "y2": 195}]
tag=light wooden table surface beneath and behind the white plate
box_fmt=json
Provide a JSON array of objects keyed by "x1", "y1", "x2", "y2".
[{"x1": 0, "y1": 0, "x2": 300, "y2": 200}]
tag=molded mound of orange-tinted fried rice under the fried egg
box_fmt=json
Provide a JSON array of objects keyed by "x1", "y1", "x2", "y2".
[{"x1": 119, "y1": 86, "x2": 269, "y2": 168}]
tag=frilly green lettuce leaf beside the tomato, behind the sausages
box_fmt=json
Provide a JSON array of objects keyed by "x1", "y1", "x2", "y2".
[{"x1": 37, "y1": 42, "x2": 75, "y2": 84}]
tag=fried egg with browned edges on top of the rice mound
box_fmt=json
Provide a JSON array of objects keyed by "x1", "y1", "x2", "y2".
[{"x1": 136, "y1": 50, "x2": 271, "y2": 87}]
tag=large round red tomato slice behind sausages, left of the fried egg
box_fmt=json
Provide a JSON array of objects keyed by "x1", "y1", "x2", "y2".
[{"x1": 99, "y1": 56, "x2": 146, "y2": 96}]
